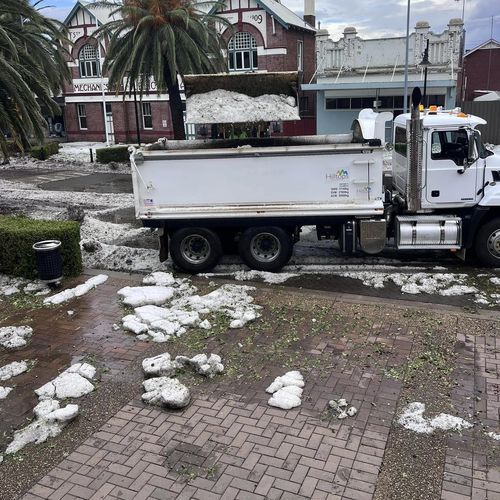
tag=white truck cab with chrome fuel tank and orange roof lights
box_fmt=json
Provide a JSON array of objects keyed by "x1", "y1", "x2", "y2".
[{"x1": 392, "y1": 106, "x2": 500, "y2": 266}]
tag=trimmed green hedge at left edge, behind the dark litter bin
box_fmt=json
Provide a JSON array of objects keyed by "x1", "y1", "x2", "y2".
[{"x1": 0, "y1": 215, "x2": 82, "y2": 279}]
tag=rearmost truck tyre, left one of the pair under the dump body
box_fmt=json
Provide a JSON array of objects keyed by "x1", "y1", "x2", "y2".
[{"x1": 170, "y1": 227, "x2": 222, "y2": 274}]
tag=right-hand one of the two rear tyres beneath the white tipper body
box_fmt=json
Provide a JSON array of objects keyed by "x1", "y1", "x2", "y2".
[{"x1": 239, "y1": 226, "x2": 293, "y2": 272}]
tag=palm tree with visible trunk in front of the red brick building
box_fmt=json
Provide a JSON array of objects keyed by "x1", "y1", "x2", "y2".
[{"x1": 94, "y1": 0, "x2": 226, "y2": 139}]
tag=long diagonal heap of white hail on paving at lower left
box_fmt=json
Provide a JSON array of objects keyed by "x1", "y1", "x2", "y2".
[{"x1": 0, "y1": 363, "x2": 96, "y2": 462}]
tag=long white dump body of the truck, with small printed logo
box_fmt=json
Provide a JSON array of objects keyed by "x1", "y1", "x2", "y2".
[{"x1": 132, "y1": 144, "x2": 383, "y2": 225}]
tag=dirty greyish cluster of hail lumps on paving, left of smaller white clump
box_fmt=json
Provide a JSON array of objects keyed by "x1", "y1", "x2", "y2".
[{"x1": 142, "y1": 353, "x2": 224, "y2": 408}]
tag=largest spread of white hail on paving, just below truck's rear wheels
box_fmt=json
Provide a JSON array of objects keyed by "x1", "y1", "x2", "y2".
[{"x1": 118, "y1": 272, "x2": 261, "y2": 342}]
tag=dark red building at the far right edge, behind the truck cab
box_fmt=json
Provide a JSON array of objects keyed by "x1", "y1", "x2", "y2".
[{"x1": 458, "y1": 40, "x2": 500, "y2": 101}]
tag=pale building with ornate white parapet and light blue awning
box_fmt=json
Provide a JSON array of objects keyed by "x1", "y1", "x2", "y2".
[{"x1": 303, "y1": 19, "x2": 463, "y2": 137}]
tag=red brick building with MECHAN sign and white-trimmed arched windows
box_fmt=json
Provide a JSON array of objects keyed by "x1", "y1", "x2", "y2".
[{"x1": 60, "y1": 0, "x2": 316, "y2": 143}]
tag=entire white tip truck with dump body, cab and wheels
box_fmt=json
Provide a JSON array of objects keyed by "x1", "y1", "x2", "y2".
[{"x1": 131, "y1": 89, "x2": 500, "y2": 273}]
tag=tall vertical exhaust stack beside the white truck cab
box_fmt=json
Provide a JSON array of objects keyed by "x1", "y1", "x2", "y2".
[{"x1": 406, "y1": 87, "x2": 423, "y2": 212}]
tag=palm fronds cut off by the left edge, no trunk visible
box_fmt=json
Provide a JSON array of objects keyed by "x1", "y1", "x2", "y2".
[{"x1": 0, "y1": 0, "x2": 69, "y2": 161}]
